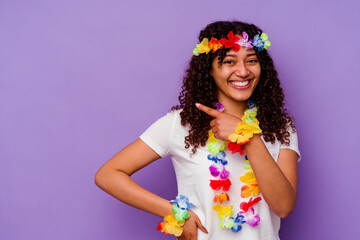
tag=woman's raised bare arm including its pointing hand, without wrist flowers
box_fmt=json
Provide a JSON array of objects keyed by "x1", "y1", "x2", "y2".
[{"x1": 197, "y1": 104, "x2": 297, "y2": 218}]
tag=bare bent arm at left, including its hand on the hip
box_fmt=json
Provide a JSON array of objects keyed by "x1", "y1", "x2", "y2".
[{"x1": 95, "y1": 139, "x2": 207, "y2": 239}]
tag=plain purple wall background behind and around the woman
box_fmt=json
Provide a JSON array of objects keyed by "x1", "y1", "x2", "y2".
[{"x1": 0, "y1": 0, "x2": 360, "y2": 240}]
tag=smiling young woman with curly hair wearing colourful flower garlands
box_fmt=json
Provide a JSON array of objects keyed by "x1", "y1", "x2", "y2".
[{"x1": 95, "y1": 22, "x2": 300, "y2": 240}]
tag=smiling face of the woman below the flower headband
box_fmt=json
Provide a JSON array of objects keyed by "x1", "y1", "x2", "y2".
[{"x1": 210, "y1": 47, "x2": 261, "y2": 102}]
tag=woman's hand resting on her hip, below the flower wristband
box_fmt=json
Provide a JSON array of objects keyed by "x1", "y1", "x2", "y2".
[{"x1": 177, "y1": 210, "x2": 208, "y2": 240}]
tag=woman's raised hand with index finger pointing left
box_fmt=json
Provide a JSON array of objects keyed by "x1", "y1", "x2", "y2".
[{"x1": 196, "y1": 103, "x2": 241, "y2": 141}]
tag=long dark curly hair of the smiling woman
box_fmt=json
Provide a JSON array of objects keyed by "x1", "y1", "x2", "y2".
[{"x1": 172, "y1": 21, "x2": 295, "y2": 153}]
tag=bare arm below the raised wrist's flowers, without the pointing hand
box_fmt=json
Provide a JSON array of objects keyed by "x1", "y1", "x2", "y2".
[{"x1": 244, "y1": 135, "x2": 297, "y2": 218}]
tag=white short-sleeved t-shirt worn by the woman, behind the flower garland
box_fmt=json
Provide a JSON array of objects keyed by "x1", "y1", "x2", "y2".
[{"x1": 140, "y1": 110, "x2": 300, "y2": 240}]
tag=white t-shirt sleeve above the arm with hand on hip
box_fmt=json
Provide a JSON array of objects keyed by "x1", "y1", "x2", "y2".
[{"x1": 139, "y1": 111, "x2": 176, "y2": 158}]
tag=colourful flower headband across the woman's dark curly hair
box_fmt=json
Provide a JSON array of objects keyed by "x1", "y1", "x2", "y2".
[{"x1": 193, "y1": 31, "x2": 271, "y2": 56}]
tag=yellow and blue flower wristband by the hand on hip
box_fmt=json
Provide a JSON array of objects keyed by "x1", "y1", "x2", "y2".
[{"x1": 156, "y1": 194, "x2": 193, "y2": 237}]
